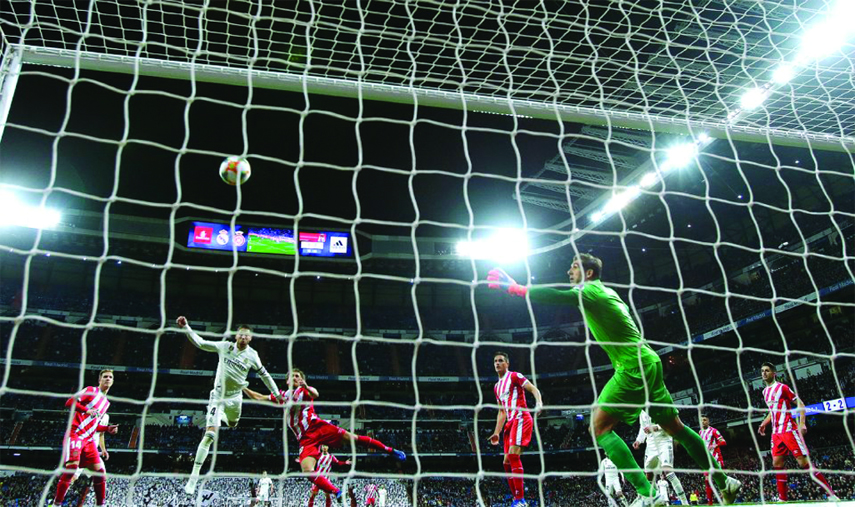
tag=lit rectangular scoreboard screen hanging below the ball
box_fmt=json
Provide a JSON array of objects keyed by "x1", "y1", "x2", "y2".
[{"x1": 187, "y1": 222, "x2": 353, "y2": 257}]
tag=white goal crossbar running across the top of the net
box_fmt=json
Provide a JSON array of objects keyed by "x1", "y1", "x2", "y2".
[{"x1": 13, "y1": 44, "x2": 855, "y2": 153}]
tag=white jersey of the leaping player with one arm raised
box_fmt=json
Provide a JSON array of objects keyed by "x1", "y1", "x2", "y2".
[{"x1": 184, "y1": 325, "x2": 279, "y2": 398}]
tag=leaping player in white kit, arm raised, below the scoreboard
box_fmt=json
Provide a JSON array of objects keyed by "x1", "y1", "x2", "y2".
[{"x1": 175, "y1": 316, "x2": 282, "y2": 495}]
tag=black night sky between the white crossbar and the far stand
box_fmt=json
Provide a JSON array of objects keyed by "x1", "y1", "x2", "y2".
[{"x1": 0, "y1": 66, "x2": 576, "y2": 234}]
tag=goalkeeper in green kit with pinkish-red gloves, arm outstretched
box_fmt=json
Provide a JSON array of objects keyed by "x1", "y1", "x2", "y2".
[{"x1": 487, "y1": 254, "x2": 742, "y2": 507}]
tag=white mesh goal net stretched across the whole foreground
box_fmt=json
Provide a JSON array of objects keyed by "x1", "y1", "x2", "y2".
[{"x1": 0, "y1": 0, "x2": 855, "y2": 506}]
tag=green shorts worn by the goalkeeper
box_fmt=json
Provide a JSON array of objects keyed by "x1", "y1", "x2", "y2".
[{"x1": 597, "y1": 361, "x2": 677, "y2": 425}]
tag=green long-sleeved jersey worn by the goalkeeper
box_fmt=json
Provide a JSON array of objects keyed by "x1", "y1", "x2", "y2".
[{"x1": 528, "y1": 280, "x2": 659, "y2": 370}]
